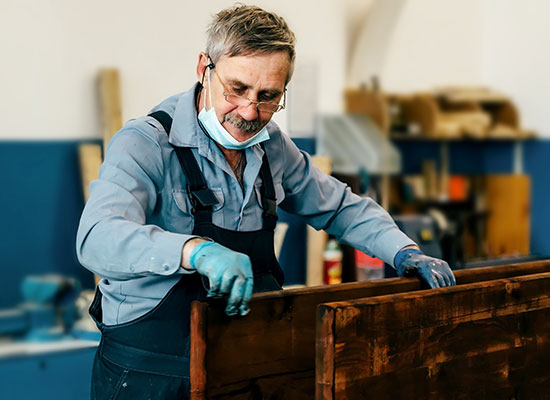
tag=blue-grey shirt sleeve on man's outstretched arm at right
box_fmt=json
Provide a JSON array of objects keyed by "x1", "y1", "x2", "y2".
[{"x1": 280, "y1": 135, "x2": 415, "y2": 266}]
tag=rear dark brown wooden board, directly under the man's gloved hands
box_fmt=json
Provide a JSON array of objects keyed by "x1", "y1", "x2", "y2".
[{"x1": 191, "y1": 260, "x2": 550, "y2": 399}]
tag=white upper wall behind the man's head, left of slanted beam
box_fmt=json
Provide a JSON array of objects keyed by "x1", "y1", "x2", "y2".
[{"x1": 0, "y1": 0, "x2": 345, "y2": 139}]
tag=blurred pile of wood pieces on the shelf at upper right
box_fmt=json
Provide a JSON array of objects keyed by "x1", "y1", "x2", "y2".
[{"x1": 345, "y1": 87, "x2": 534, "y2": 139}]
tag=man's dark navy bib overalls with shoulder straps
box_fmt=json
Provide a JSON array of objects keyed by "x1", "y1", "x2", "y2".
[{"x1": 90, "y1": 111, "x2": 283, "y2": 400}]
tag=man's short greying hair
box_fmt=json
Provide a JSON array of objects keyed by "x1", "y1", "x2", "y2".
[{"x1": 206, "y1": 3, "x2": 296, "y2": 83}]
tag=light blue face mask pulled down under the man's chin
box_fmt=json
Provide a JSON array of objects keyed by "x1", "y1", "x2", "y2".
[{"x1": 199, "y1": 71, "x2": 269, "y2": 150}]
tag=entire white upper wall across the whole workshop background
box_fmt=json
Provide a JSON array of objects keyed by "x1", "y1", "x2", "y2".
[{"x1": 0, "y1": 0, "x2": 550, "y2": 139}]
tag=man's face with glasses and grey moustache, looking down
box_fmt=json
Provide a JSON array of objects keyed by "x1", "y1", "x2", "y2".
[{"x1": 197, "y1": 52, "x2": 290, "y2": 142}]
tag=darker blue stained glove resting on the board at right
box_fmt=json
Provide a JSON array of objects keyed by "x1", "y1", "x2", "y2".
[{"x1": 394, "y1": 249, "x2": 456, "y2": 289}]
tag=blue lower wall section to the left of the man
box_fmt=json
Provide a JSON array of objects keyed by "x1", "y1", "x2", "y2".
[{"x1": 0, "y1": 141, "x2": 97, "y2": 308}]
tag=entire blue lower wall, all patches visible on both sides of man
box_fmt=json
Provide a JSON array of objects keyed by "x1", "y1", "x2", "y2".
[{"x1": 0, "y1": 139, "x2": 550, "y2": 300}]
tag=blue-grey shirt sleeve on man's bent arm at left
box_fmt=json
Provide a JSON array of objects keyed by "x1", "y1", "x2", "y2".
[{"x1": 76, "y1": 128, "x2": 194, "y2": 280}]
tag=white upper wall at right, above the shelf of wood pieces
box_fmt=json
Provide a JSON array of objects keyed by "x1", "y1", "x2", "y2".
[{"x1": 347, "y1": 0, "x2": 550, "y2": 137}]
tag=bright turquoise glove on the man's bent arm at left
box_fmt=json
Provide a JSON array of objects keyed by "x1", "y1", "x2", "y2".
[{"x1": 189, "y1": 242, "x2": 254, "y2": 316}]
